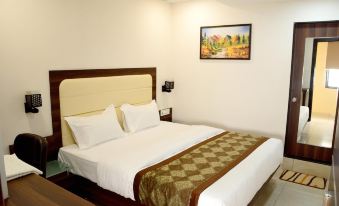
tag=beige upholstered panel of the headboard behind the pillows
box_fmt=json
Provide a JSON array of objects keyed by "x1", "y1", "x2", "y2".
[{"x1": 59, "y1": 74, "x2": 152, "y2": 146}]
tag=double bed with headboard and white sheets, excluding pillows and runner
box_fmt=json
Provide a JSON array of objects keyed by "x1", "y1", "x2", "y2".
[{"x1": 50, "y1": 68, "x2": 283, "y2": 206}]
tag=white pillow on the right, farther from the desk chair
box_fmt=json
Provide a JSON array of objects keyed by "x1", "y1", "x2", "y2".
[{"x1": 120, "y1": 100, "x2": 160, "y2": 132}]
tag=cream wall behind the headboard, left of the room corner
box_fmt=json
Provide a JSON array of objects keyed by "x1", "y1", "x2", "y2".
[{"x1": 0, "y1": 0, "x2": 171, "y2": 151}]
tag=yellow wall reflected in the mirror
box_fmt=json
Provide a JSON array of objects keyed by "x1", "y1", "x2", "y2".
[{"x1": 312, "y1": 42, "x2": 338, "y2": 118}]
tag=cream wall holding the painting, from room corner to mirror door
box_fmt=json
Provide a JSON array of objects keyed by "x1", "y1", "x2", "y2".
[{"x1": 171, "y1": 0, "x2": 339, "y2": 139}]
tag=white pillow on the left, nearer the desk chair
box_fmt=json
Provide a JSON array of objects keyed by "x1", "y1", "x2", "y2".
[{"x1": 65, "y1": 105, "x2": 125, "y2": 149}]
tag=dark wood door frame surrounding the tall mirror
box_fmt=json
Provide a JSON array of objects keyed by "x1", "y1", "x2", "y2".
[{"x1": 284, "y1": 21, "x2": 339, "y2": 164}]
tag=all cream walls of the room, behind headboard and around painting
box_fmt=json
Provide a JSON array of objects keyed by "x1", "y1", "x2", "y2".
[{"x1": 0, "y1": 0, "x2": 339, "y2": 151}]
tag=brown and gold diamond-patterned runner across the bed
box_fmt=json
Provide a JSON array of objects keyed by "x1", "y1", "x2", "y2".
[{"x1": 133, "y1": 132, "x2": 268, "y2": 206}]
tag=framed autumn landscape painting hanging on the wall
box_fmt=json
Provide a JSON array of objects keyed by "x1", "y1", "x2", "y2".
[{"x1": 200, "y1": 24, "x2": 252, "y2": 60}]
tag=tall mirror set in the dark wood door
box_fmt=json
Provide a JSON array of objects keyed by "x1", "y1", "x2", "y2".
[{"x1": 297, "y1": 38, "x2": 339, "y2": 148}]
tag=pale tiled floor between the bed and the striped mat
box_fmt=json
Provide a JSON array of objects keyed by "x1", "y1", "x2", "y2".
[{"x1": 250, "y1": 168, "x2": 324, "y2": 206}]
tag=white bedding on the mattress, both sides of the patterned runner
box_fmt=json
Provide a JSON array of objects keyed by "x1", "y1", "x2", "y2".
[{"x1": 59, "y1": 122, "x2": 283, "y2": 206}]
